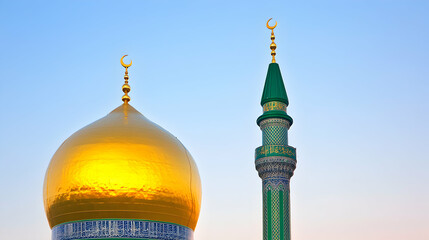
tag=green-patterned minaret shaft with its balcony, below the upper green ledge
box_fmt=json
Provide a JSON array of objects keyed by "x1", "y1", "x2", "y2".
[{"x1": 255, "y1": 113, "x2": 296, "y2": 240}]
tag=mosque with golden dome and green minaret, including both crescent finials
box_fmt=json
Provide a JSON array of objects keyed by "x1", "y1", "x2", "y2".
[{"x1": 43, "y1": 19, "x2": 296, "y2": 240}]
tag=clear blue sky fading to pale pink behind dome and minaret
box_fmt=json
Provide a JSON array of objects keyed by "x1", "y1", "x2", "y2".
[{"x1": 0, "y1": 0, "x2": 429, "y2": 240}]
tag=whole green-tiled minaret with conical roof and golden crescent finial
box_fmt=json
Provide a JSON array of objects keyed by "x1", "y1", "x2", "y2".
[{"x1": 255, "y1": 19, "x2": 296, "y2": 240}]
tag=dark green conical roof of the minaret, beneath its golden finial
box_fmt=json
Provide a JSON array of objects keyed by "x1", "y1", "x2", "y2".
[{"x1": 261, "y1": 63, "x2": 289, "y2": 105}]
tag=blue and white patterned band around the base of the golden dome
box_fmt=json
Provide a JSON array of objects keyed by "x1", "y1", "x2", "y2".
[{"x1": 52, "y1": 219, "x2": 194, "y2": 240}]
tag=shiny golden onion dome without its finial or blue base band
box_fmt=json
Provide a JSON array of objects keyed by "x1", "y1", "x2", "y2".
[{"x1": 44, "y1": 102, "x2": 201, "y2": 230}]
